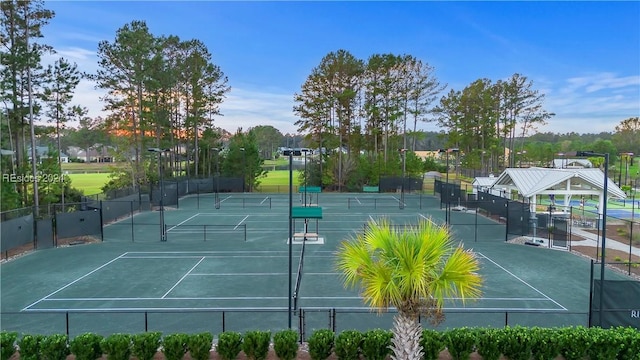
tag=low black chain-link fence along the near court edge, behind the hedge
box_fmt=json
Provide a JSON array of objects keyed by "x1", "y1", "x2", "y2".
[{"x1": 0, "y1": 307, "x2": 589, "y2": 342}]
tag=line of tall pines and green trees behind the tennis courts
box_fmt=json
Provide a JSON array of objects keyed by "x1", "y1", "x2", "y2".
[{"x1": 0, "y1": 0, "x2": 640, "y2": 209}]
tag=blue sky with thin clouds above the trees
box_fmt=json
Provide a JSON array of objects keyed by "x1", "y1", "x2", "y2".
[{"x1": 43, "y1": 1, "x2": 640, "y2": 133}]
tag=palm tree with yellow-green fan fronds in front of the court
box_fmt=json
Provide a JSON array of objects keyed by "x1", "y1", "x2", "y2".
[{"x1": 336, "y1": 218, "x2": 482, "y2": 360}]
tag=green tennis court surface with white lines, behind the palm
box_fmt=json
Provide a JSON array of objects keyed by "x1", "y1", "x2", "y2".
[{"x1": 2, "y1": 194, "x2": 618, "y2": 335}]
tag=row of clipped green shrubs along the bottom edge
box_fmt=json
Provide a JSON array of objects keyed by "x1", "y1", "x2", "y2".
[{"x1": 0, "y1": 327, "x2": 640, "y2": 360}]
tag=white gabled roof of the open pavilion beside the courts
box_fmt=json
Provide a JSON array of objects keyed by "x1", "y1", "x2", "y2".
[{"x1": 493, "y1": 167, "x2": 627, "y2": 199}]
